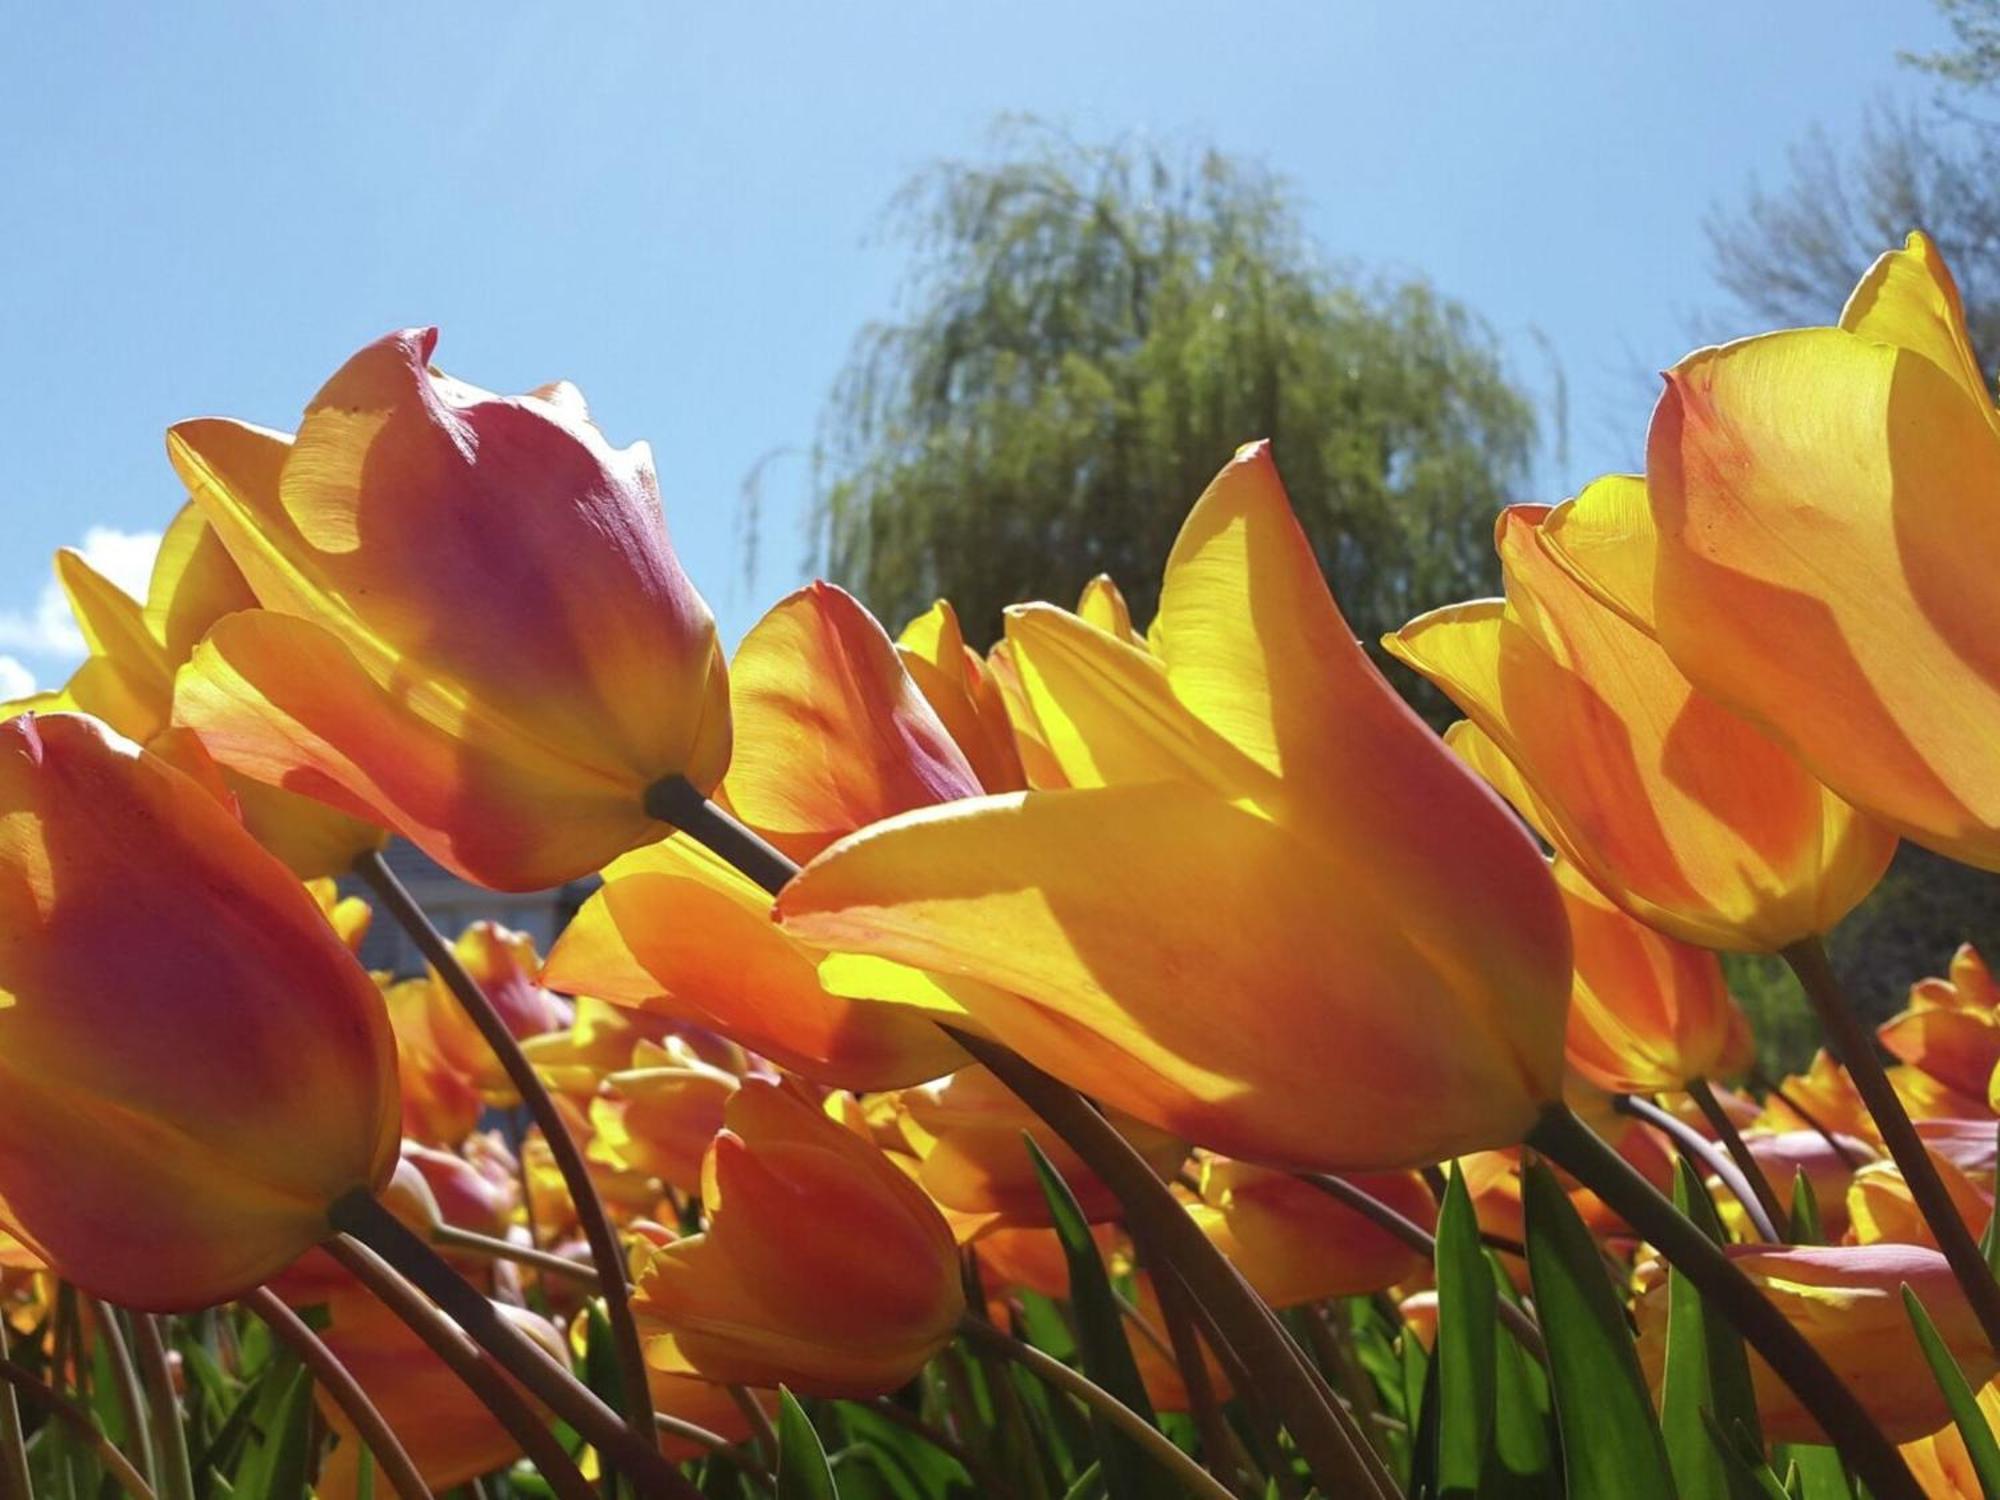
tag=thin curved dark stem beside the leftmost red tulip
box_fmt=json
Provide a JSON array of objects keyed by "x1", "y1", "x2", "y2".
[{"x1": 354, "y1": 850, "x2": 652, "y2": 1440}]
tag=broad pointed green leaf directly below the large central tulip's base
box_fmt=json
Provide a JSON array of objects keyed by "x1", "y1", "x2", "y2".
[{"x1": 1522, "y1": 1162, "x2": 1674, "y2": 1500}]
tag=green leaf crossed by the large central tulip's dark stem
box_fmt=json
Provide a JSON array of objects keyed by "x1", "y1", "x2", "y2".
[{"x1": 1660, "y1": 1158, "x2": 1760, "y2": 1500}]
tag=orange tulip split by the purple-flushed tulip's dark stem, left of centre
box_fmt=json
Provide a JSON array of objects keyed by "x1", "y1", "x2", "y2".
[{"x1": 544, "y1": 584, "x2": 980, "y2": 1090}]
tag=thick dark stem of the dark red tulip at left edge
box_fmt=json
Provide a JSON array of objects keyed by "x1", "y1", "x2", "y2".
[{"x1": 326, "y1": 1188, "x2": 700, "y2": 1500}]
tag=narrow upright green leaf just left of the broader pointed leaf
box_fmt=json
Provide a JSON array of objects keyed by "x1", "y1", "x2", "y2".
[{"x1": 1436, "y1": 1162, "x2": 1498, "y2": 1496}]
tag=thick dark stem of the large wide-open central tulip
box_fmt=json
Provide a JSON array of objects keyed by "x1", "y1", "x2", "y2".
[{"x1": 1526, "y1": 1104, "x2": 1922, "y2": 1500}]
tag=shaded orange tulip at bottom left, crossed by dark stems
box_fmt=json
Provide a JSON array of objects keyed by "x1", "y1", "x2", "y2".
[{"x1": 314, "y1": 1296, "x2": 570, "y2": 1500}]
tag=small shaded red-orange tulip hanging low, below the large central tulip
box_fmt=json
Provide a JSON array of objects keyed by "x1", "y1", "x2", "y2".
[{"x1": 634, "y1": 1080, "x2": 964, "y2": 1396}]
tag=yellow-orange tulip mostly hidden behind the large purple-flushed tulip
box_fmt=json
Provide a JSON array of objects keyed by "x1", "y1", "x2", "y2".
[{"x1": 0, "y1": 504, "x2": 388, "y2": 880}]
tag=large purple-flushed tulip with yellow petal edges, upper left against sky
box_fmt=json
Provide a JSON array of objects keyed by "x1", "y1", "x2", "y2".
[{"x1": 168, "y1": 330, "x2": 730, "y2": 890}]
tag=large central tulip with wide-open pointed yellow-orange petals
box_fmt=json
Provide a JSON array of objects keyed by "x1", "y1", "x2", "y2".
[{"x1": 778, "y1": 446, "x2": 1570, "y2": 1170}]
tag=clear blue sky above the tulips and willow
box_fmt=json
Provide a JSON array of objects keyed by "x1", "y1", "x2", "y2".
[{"x1": 0, "y1": 0, "x2": 1944, "y2": 696}]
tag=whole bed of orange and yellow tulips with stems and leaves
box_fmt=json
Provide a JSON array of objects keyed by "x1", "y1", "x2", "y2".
[{"x1": 0, "y1": 236, "x2": 2000, "y2": 1500}]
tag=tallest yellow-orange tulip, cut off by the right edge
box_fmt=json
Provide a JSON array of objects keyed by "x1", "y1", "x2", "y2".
[{"x1": 1564, "y1": 234, "x2": 2000, "y2": 870}]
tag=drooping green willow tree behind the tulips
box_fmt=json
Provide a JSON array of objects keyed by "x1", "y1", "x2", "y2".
[{"x1": 812, "y1": 126, "x2": 1536, "y2": 708}]
